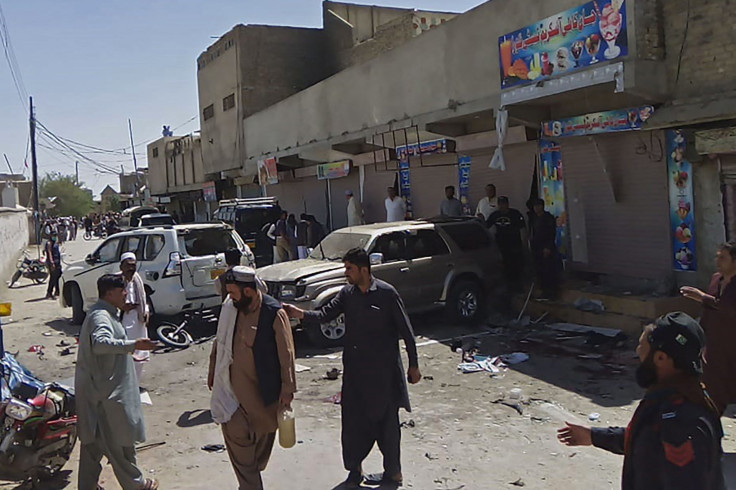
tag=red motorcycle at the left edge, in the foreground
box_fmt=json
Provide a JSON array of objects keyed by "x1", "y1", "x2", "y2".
[{"x1": 0, "y1": 353, "x2": 77, "y2": 485}]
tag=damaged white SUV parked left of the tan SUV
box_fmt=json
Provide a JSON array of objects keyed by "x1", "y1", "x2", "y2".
[{"x1": 60, "y1": 223, "x2": 255, "y2": 324}]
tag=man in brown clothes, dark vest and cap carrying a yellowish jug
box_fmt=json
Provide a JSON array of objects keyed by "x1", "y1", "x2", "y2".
[{"x1": 207, "y1": 266, "x2": 296, "y2": 490}]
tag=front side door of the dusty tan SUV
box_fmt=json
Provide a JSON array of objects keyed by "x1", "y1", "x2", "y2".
[{"x1": 370, "y1": 231, "x2": 418, "y2": 308}]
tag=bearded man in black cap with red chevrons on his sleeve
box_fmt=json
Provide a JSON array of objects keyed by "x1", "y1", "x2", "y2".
[{"x1": 557, "y1": 312, "x2": 726, "y2": 490}]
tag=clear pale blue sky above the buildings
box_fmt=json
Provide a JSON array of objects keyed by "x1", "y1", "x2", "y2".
[{"x1": 0, "y1": 0, "x2": 484, "y2": 196}]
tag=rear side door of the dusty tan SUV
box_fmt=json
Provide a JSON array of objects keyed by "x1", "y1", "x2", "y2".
[{"x1": 406, "y1": 229, "x2": 453, "y2": 308}]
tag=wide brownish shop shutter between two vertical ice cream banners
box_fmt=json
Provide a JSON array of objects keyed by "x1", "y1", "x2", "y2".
[{"x1": 559, "y1": 131, "x2": 672, "y2": 279}]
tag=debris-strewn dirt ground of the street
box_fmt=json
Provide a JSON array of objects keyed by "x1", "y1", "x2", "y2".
[{"x1": 0, "y1": 237, "x2": 736, "y2": 490}]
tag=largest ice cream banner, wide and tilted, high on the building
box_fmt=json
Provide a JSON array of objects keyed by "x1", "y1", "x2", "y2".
[{"x1": 498, "y1": 0, "x2": 629, "y2": 88}]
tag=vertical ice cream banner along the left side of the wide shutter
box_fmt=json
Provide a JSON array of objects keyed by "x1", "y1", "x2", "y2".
[{"x1": 539, "y1": 140, "x2": 567, "y2": 258}]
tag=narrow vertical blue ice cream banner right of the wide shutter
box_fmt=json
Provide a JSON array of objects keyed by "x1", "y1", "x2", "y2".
[{"x1": 667, "y1": 130, "x2": 698, "y2": 271}]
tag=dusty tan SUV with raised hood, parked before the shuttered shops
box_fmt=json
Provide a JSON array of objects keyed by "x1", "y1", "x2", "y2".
[{"x1": 258, "y1": 218, "x2": 502, "y2": 347}]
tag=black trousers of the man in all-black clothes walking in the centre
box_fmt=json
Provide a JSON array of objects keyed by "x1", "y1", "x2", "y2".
[{"x1": 342, "y1": 398, "x2": 401, "y2": 476}]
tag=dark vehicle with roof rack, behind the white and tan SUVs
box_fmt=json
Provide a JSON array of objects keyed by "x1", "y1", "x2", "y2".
[{"x1": 215, "y1": 197, "x2": 281, "y2": 267}]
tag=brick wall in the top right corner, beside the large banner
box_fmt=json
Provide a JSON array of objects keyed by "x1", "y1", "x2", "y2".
[{"x1": 660, "y1": 0, "x2": 736, "y2": 99}]
